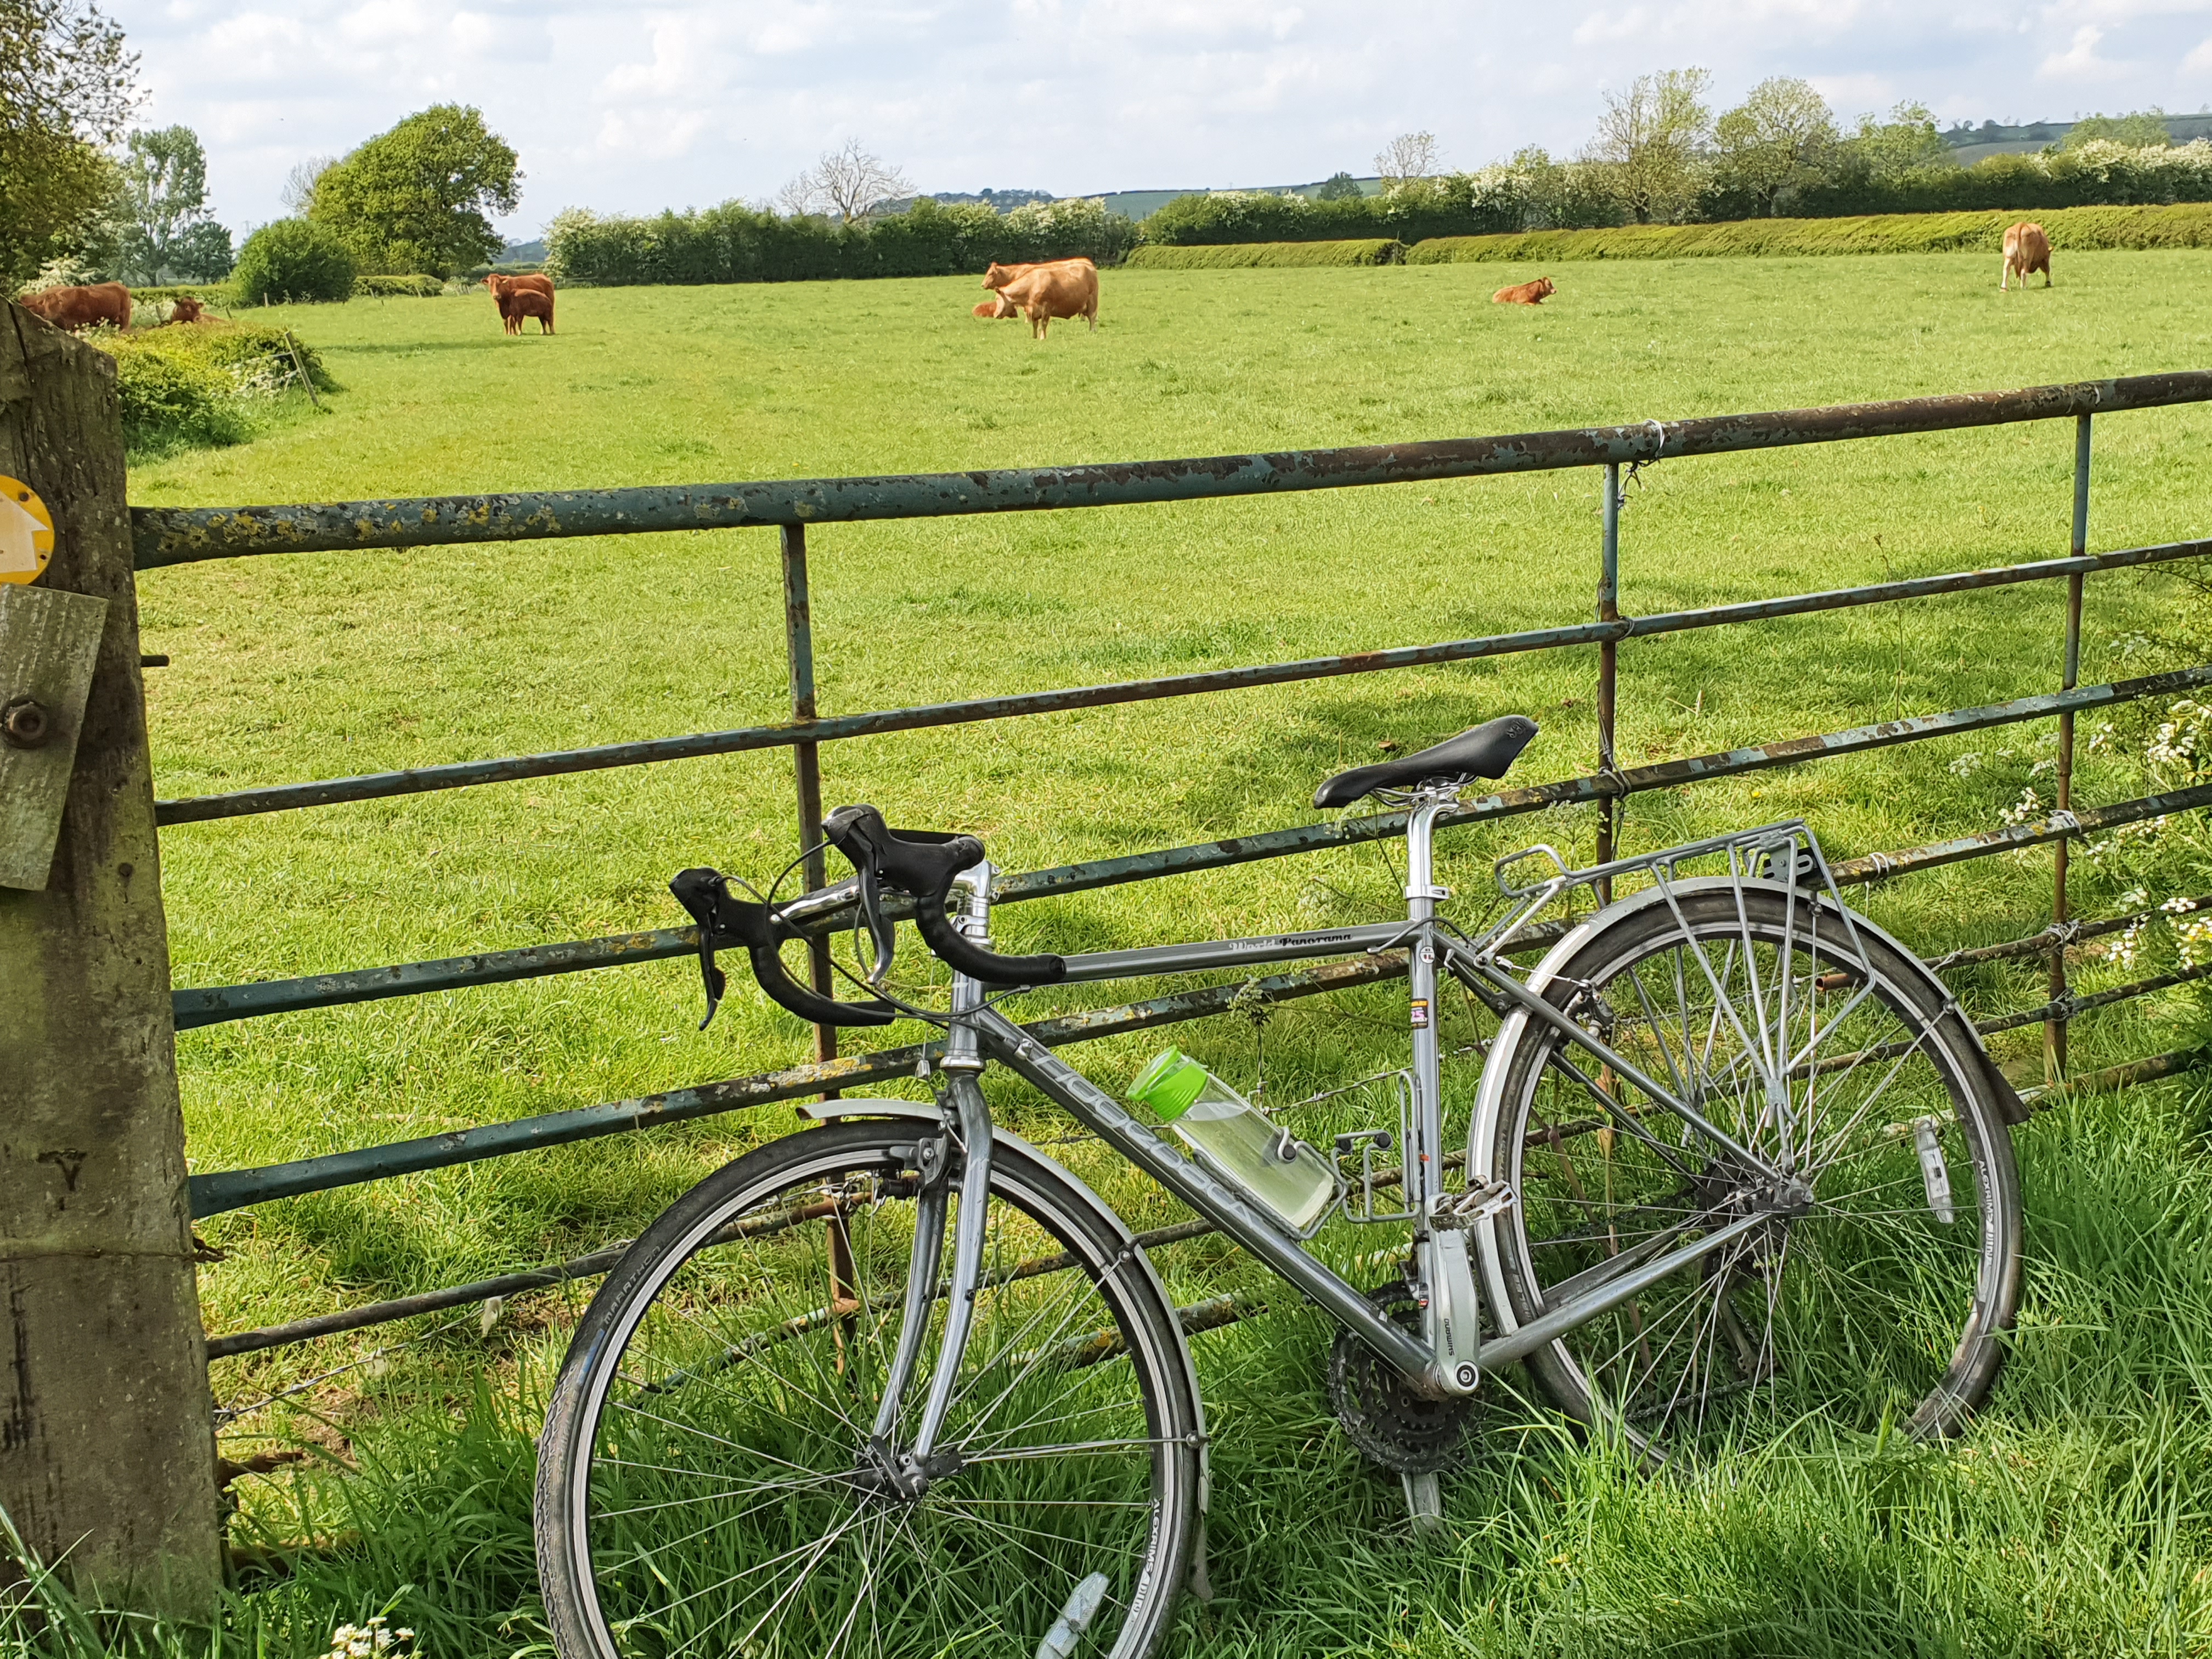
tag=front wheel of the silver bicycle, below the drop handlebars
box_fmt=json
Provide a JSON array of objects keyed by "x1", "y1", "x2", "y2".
[{"x1": 538, "y1": 1119, "x2": 1199, "y2": 1659}]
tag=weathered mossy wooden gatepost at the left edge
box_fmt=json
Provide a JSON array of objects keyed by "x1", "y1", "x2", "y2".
[{"x1": 0, "y1": 305, "x2": 221, "y2": 1617}]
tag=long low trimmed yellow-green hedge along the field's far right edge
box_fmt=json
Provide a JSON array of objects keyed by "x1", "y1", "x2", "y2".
[{"x1": 1404, "y1": 204, "x2": 2212, "y2": 266}]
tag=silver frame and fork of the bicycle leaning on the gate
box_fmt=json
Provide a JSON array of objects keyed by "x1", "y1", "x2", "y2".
[{"x1": 878, "y1": 789, "x2": 1825, "y2": 1415}]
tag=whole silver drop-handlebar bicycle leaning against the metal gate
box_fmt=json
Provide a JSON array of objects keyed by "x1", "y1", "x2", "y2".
[{"x1": 538, "y1": 716, "x2": 2024, "y2": 1659}]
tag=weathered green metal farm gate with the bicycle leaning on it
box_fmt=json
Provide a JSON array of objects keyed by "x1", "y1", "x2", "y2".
[{"x1": 0, "y1": 327, "x2": 2212, "y2": 1610}]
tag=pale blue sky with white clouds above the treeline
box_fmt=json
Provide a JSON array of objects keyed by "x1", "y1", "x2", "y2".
[{"x1": 99, "y1": 0, "x2": 2212, "y2": 239}]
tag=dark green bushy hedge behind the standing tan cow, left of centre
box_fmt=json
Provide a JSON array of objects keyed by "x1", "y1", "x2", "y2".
[{"x1": 546, "y1": 197, "x2": 1137, "y2": 287}]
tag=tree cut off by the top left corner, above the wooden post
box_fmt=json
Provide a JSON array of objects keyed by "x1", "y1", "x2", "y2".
[{"x1": 0, "y1": 0, "x2": 139, "y2": 292}]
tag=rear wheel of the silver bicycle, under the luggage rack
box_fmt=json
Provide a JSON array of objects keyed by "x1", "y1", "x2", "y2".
[{"x1": 1469, "y1": 881, "x2": 2022, "y2": 1458}]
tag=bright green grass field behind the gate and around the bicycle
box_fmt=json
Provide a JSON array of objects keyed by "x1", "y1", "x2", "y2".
[{"x1": 86, "y1": 252, "x2": 2212, "y2": 1659}]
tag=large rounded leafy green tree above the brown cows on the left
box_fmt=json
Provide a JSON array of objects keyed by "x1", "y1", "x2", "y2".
[{"x1": 307, "y1": 104, "x2": 522, "y2": 276}]
